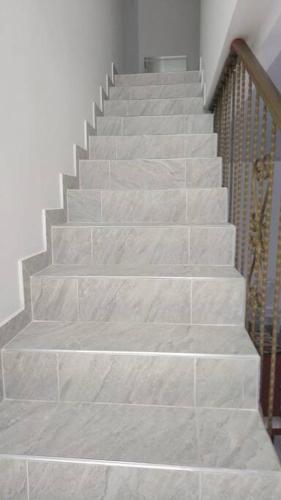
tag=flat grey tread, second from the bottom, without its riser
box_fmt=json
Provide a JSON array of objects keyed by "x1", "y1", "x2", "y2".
[{"x1": 4, "y1": 321, "x2": 258, "y2": 358}]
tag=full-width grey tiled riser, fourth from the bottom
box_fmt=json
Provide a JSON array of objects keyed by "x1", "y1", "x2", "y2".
[{"x1": 52, "y1": 226, "x2": 235, "y2": 266}]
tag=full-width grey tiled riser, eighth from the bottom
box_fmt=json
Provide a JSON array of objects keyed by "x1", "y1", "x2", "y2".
[{"x1": 97, "y1": 114, "x2": 214, "y2": 136}]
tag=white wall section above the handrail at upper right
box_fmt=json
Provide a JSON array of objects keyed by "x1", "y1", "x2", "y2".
[{"x1": 200, "y1": 0, "x2": 280, "y2": 105}]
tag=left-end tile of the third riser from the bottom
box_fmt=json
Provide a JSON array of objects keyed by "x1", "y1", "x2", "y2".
[{"x1": 31, "y1": 276, "x2": 78, "y2": 321}]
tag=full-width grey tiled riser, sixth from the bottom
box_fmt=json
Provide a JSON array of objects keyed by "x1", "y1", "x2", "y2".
[{"x1": 79, "y1": 158, "x2": 222, "y2": 189}]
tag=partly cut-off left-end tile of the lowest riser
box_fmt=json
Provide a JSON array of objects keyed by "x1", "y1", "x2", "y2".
[{"x1": 0, "y1": 458, "x2": 27, "y2": 500}]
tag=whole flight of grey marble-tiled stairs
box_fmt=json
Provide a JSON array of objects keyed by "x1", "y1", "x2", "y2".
[{"x1": 0, "y1": 72, "x2": 281, "y2": 500}]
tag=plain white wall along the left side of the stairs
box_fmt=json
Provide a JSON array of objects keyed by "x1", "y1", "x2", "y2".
[{"x1": 0, "y1": 0, "x2": 124, "y2": 322}]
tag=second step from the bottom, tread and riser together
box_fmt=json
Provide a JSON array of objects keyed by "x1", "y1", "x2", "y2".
[{"x1": 2, "y1": 322, "x2": 259, "y2": 409}]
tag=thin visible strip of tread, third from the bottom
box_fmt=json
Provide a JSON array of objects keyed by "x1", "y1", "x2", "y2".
[{"x1": 34, "y1": 264, "x2": 242, "y2": 279}]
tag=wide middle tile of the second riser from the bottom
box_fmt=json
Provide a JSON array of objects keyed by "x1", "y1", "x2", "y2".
[{"x1": 59, "y1": 353, "x2": 194, "y2": 406}]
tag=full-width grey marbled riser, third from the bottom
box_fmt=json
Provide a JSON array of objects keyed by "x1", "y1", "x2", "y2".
[{"x1": 31, "y1": 276, "x2": 245, "y2": 325}]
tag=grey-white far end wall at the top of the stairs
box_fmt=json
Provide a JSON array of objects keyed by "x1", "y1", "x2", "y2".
[{"x1": 138, "y1": 0, "x2": 200, "y2": 71}]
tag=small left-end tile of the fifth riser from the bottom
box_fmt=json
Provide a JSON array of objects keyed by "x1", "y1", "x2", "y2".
[{"x1": 68, "y1": 189, "x2": 101, "y2": 222}]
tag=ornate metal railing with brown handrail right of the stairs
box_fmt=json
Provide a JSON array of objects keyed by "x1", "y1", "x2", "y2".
[{"x1": 211, "y1": 39, "x2": 281, "y2": 436}]
